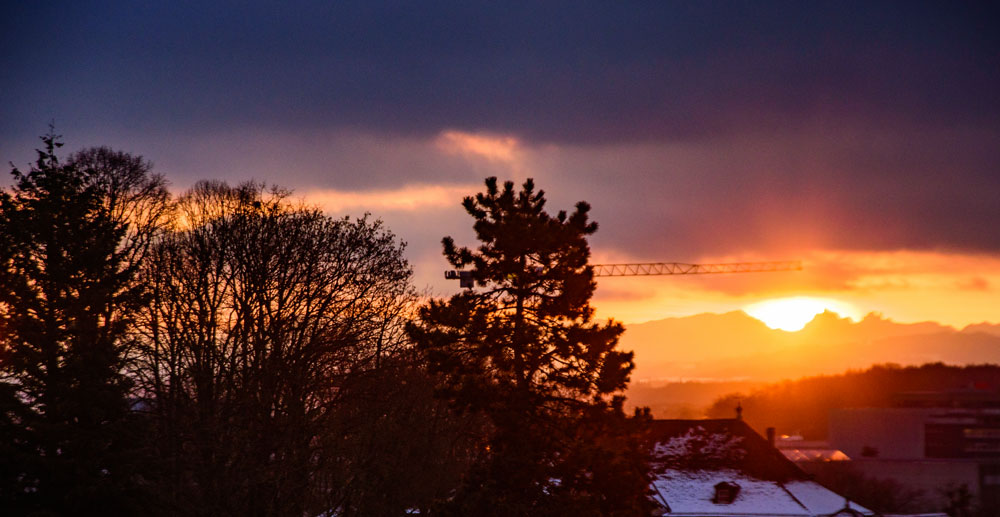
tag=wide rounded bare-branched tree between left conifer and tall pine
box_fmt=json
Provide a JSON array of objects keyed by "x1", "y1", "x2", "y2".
[{"x1": 140, "y1": 182, "x2": 420, "y2": 516}]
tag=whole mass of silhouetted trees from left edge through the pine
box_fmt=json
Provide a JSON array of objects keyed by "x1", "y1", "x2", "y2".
[{"x1": 0, "y1": 134, "x2": 651, "y2": 516}]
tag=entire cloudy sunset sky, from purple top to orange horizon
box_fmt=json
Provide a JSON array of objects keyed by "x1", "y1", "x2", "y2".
[{"x1": 0, "y1": 1, "x2": 1000, "y2": 328}]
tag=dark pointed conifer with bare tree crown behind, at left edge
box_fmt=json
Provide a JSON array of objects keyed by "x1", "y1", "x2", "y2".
[{"x1": 0, "y1": 133, "x2": 168, "y2": 514}]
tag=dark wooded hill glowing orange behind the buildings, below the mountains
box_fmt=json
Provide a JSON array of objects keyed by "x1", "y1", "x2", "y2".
[{"x1": 707, "y1": 363, "x2": 1000, "y2": 439}]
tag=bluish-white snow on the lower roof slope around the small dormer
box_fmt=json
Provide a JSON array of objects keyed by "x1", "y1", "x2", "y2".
[{"x1": 653, "y1": 470, "x2": 872, "y2": 517}]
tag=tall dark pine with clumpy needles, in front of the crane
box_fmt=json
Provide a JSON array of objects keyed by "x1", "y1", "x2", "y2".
[{"x1": 409, "y1": 178, "x2": 651, "y2": 515}]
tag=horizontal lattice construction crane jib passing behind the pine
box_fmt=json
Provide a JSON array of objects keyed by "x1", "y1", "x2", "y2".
[{"x1": 444, "y1": 260, "x2": 802, "y2": 289}]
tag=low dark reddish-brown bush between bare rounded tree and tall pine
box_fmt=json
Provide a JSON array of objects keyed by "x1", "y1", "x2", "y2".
[{"x1": 330, "y1": 352, "x2": 483, "y2": 517}]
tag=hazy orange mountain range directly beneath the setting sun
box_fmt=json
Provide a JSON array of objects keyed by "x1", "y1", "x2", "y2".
[{"x1": 621, "y1": 311, "x2": 1000, "y2": 385}]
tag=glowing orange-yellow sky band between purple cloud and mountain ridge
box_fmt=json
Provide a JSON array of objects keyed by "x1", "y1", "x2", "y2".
[{"x1": 594, "y1": 250, "x2": 1000, "y2": 328}]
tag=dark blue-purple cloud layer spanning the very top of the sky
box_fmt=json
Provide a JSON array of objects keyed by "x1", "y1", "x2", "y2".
[{"x1": 2, "y1": 2, "x2": 1000, "y2": 142}]
